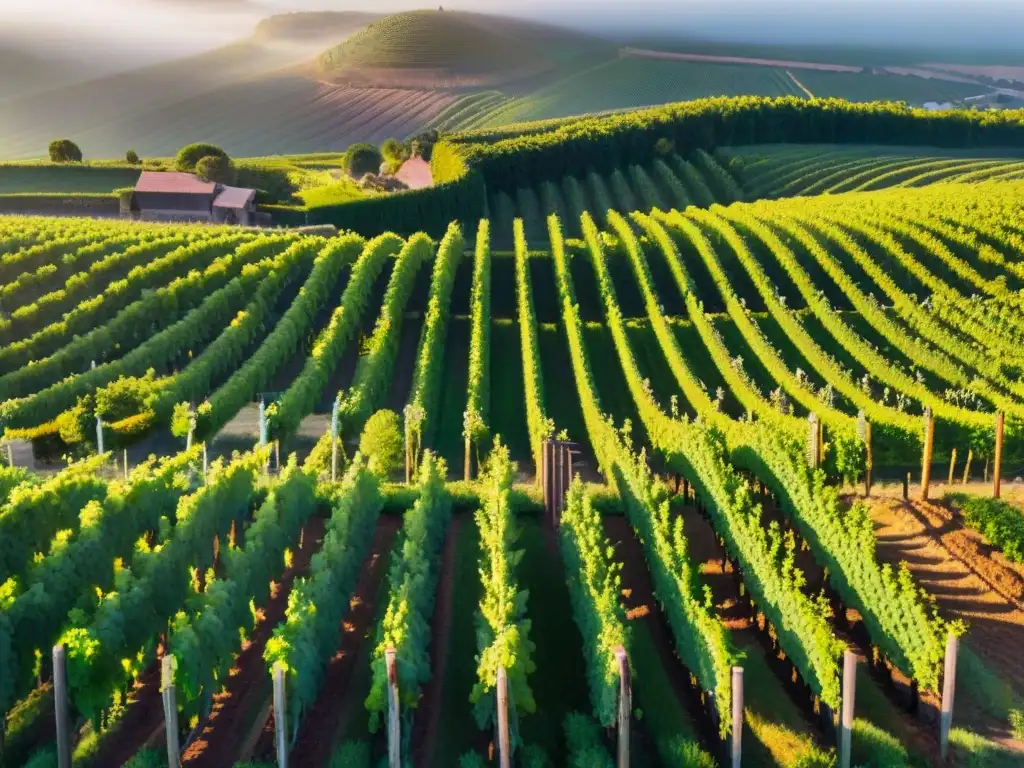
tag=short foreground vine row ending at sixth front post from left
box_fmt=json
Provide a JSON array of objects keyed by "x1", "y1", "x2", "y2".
[{"x1": 558, "y1": 477, "x2": 630, "y2": 728}]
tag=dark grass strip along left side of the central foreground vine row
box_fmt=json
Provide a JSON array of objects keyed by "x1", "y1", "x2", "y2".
[{"x1": 432, "y1": 513, "x2": 481, "y2": 768}]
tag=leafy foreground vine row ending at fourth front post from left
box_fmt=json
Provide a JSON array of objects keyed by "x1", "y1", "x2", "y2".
[{"x1": 366, "y1": 451, "x2": 452, "y2": 730}]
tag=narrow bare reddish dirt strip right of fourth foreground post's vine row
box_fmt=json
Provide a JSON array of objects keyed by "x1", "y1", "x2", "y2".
[{"x1": 412, "y1": 514, "x2": 466, "y2": 766}]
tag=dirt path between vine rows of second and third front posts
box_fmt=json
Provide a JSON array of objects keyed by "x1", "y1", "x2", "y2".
[{"x1": 181, "y1": 516, "x2": 326, "y2": 768}]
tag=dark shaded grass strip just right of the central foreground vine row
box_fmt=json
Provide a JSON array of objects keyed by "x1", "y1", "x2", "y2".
[{"x1": 516, "y1": 516, "x2": 591, "y2": 765}]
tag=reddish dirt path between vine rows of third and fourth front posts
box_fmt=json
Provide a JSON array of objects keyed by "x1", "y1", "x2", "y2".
[{"x1": 280, "y1": 515, "x2": 401, "y2": 768}]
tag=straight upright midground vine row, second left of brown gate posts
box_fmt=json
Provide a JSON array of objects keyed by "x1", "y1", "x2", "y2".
[{"x1": 463, "y1": 219, "x2": 490, "y2": 468}]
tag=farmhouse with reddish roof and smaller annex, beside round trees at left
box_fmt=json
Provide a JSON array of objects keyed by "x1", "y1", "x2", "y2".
[{"x1": 131, "y1": 171, "x2": 256, "y2": 225}]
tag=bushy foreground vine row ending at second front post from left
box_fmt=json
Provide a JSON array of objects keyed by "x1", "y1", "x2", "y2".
[{"x1": 168, "y1": 456, "x2": 316, "y2": 718}]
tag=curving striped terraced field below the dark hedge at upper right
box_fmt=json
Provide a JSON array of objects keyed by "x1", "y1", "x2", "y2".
[{"x1": 719, "y1": 144, "x2": 1024, "y2": 200}]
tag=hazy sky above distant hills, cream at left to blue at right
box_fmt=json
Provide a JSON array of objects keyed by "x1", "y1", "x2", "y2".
[{"x1": 0, "y1": 0, "x2": 1024, "y2": 66}]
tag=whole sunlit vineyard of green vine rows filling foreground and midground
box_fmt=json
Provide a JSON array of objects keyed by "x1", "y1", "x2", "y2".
[{"x1": 0, "y1": 124, "x2": 1024, "y2": 766}]
